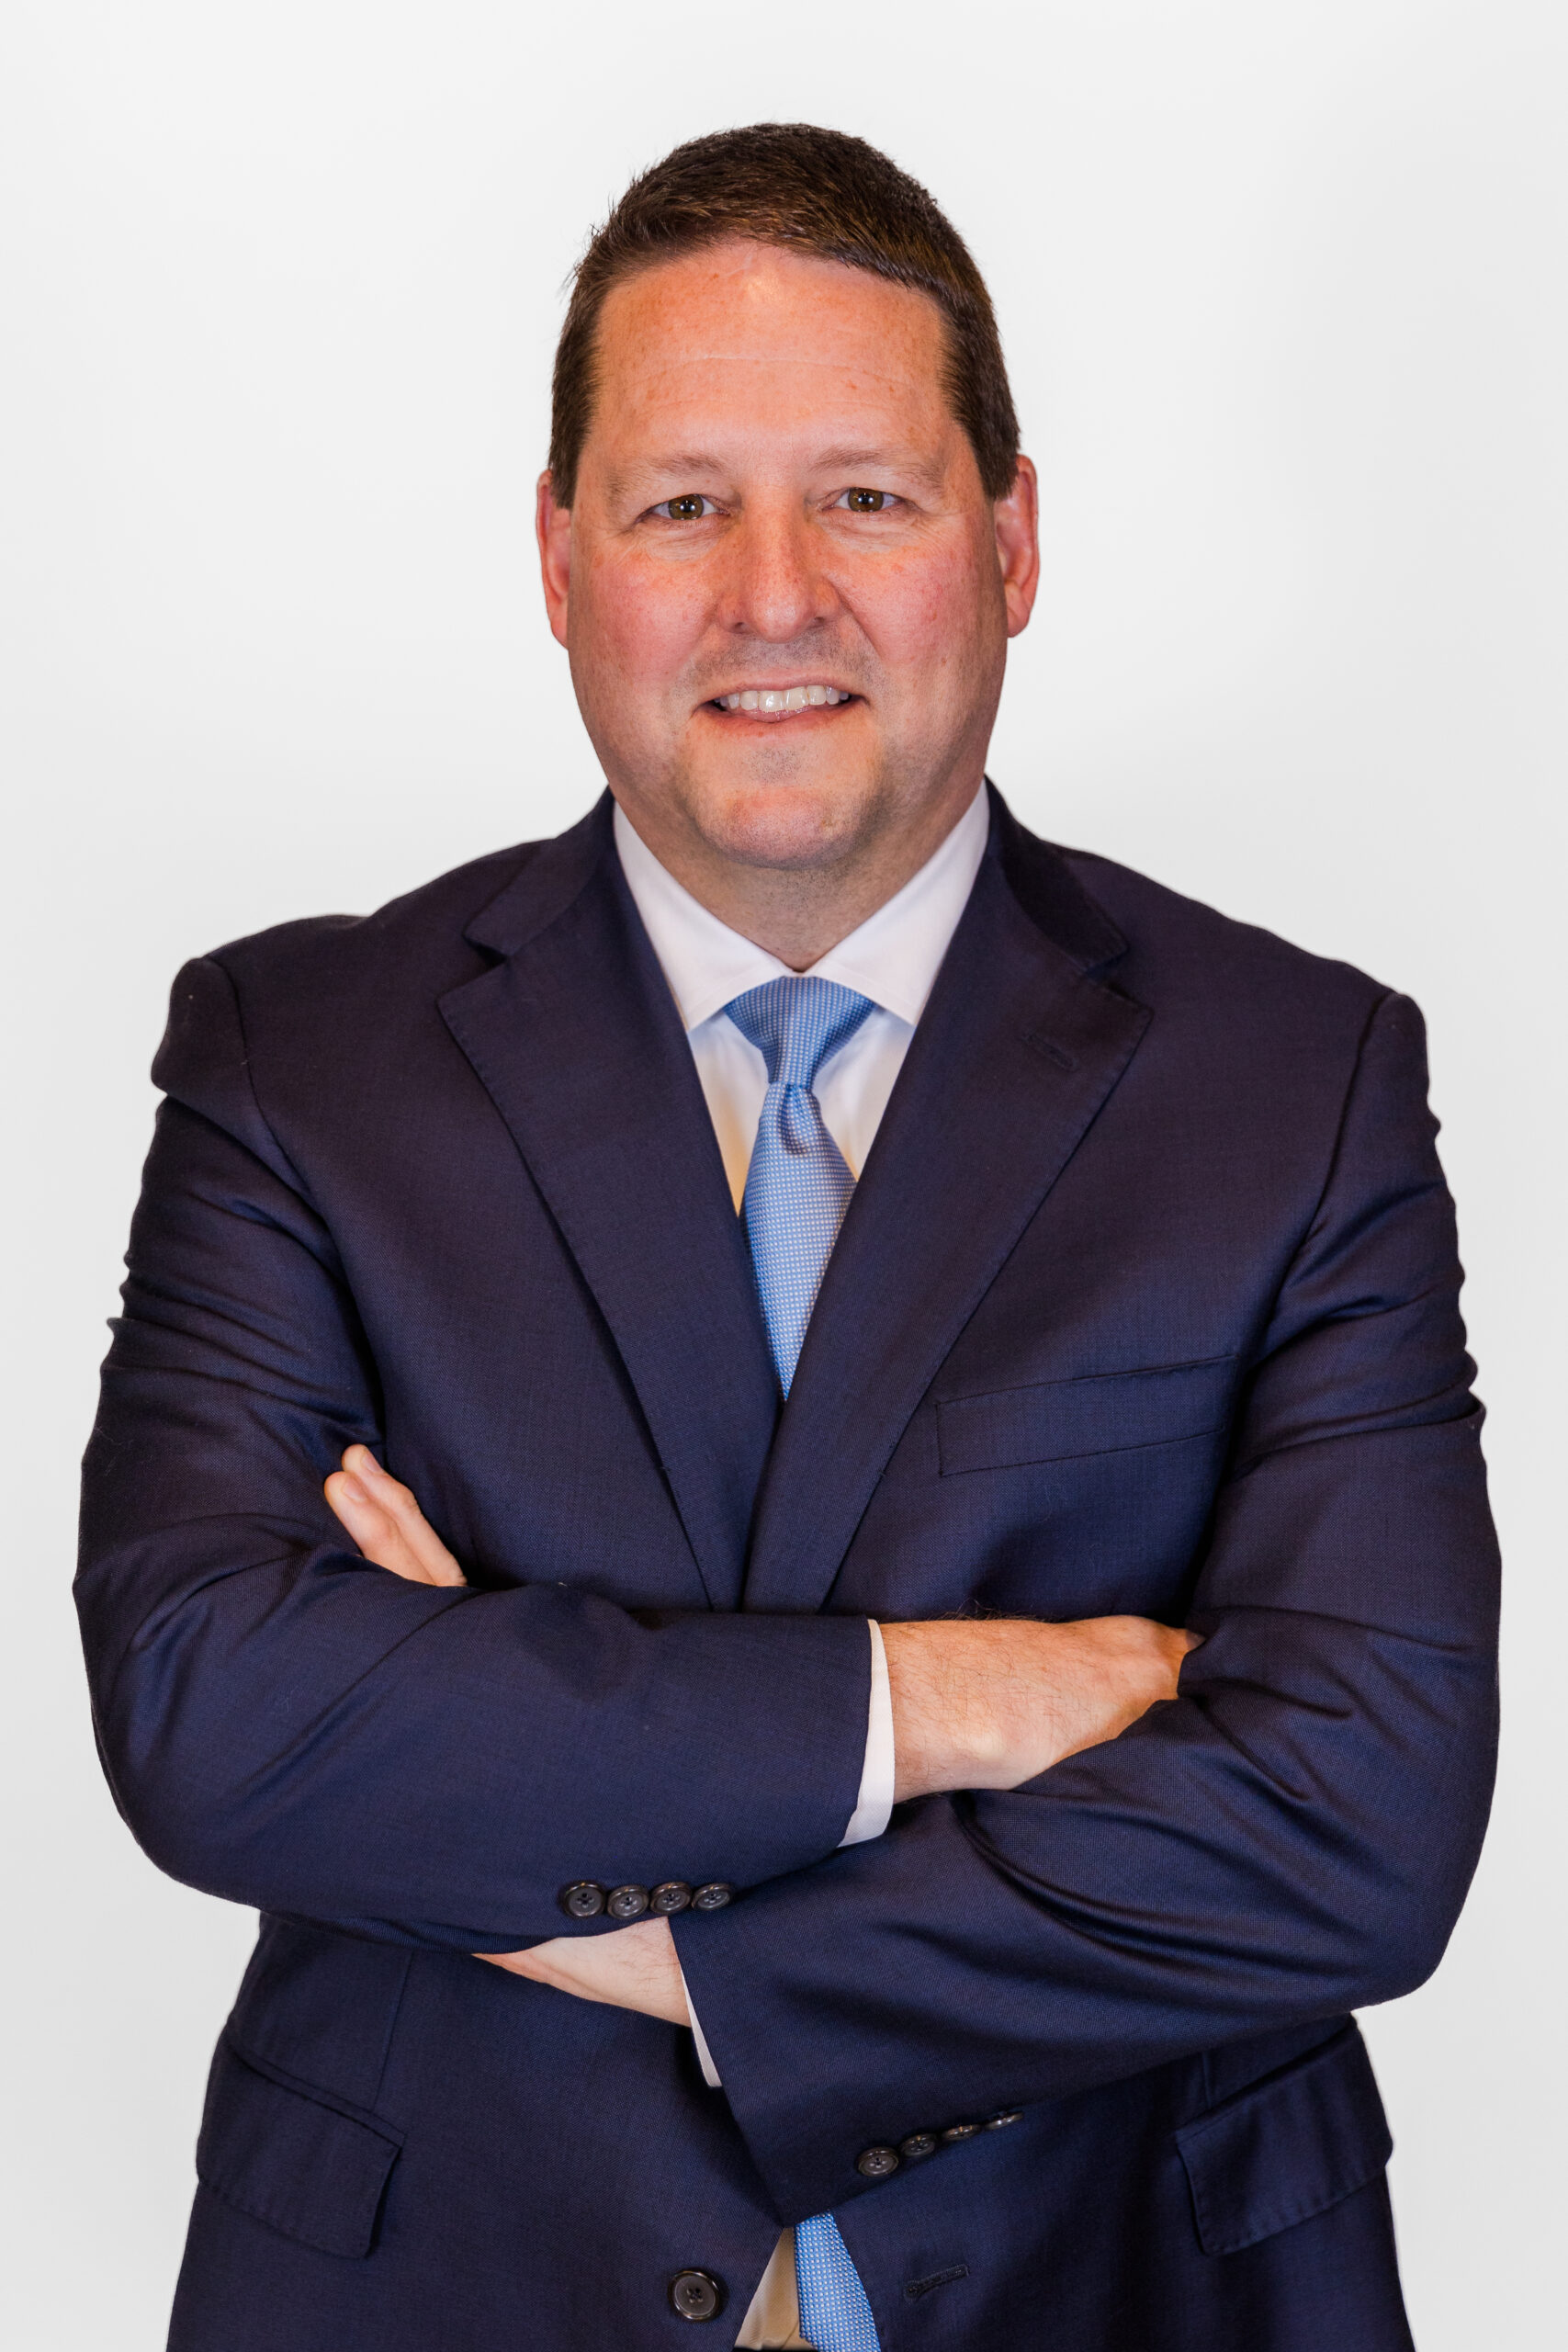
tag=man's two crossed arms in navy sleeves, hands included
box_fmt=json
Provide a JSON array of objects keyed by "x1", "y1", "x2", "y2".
[{"x1": 77, "y1": 973, "x2": 1495, "y2": 2218}]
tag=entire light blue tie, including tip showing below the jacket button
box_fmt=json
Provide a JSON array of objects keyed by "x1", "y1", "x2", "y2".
[{"x1": 724, "y1": 978, "x2": 877, "y2": 2352}]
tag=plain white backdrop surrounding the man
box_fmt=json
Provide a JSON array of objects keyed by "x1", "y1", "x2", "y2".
[{"x1": 0, "y1": 0, "x2": 1568, "y2": 2352}]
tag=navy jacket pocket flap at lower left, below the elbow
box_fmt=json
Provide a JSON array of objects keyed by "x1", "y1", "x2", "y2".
[{"x1": 195, "y1": 2041, "x2": 400, "y2": 2258}]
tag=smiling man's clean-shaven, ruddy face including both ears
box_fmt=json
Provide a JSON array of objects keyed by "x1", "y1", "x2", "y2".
[{"x1": 541, "y1": 243, "x2": 1037, "y2": 893}]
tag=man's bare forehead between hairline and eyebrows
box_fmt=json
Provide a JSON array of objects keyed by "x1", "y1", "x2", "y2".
[{"x1": 590, "y1": 240, "x2": 952, "y2": 447}]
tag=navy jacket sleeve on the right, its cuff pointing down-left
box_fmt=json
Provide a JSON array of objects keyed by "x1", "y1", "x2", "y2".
[{"x1": 677, "y1": 997, "x2": 1495, "y2": 2218}]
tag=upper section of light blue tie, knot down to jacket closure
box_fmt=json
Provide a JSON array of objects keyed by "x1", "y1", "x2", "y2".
[{"x1": 724, "y1": 978, "x2": 874, "y2": 1397}]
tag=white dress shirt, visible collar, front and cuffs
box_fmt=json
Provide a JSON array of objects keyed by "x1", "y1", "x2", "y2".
[{"x1": 616, "y1": 786, "x2": 989, "y2": 2345}]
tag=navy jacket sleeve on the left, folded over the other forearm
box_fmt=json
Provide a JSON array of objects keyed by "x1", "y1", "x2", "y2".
[{"x1": 77, "y1": 959, "x2": 870, "y2": 1952}]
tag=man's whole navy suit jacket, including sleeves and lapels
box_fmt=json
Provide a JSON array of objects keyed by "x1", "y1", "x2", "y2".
[{"x1": 77, "y1": 799, "x2": 1495, "y2": 2352}]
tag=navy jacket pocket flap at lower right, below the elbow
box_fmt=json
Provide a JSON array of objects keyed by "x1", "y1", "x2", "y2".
[{"x1": 1176, "y1": 2025, "x2": 1394, "y2": 2253}]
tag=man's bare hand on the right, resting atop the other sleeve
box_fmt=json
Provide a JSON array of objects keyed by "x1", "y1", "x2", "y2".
[{"x1": 882, "y1": 1618, "x2": 1201, "y2": 1802}]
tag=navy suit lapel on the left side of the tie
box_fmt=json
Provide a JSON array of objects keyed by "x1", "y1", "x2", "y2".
[{"x1": 442, "y1": 799, "x2": 778, "y2": 1609}]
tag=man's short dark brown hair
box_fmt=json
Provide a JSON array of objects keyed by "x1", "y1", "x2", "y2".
[{"x1": 550, "y1": 122, "x2": 1018, "y2": 505}]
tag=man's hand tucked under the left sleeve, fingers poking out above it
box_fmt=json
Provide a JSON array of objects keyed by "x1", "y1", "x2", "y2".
[{"x1": 324, "y1": 1446, "x2": 691, "y2": 2025}]
